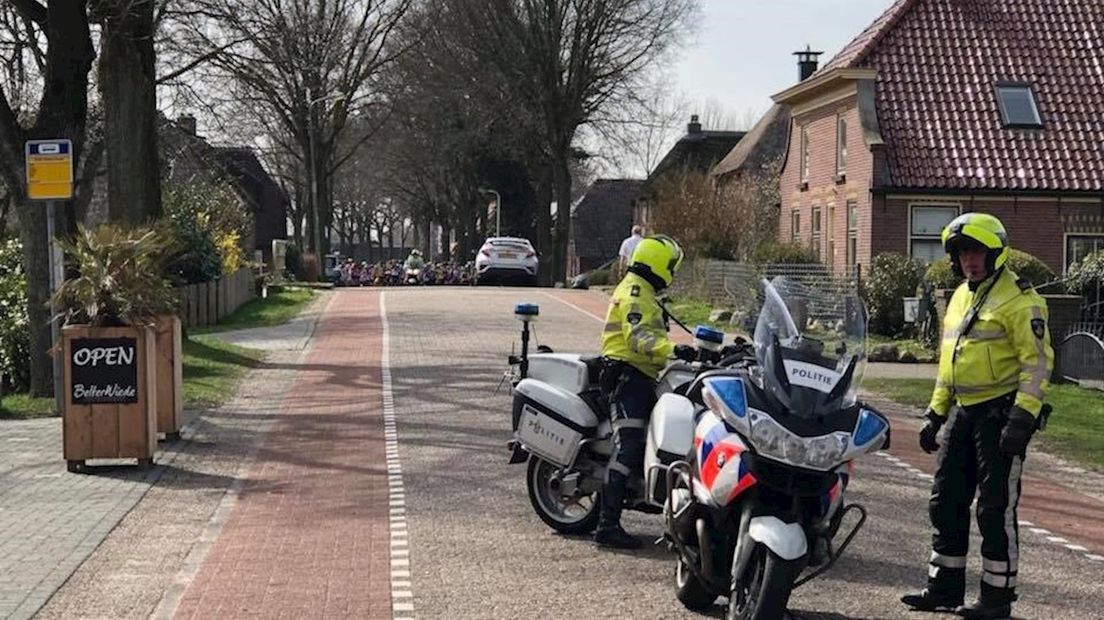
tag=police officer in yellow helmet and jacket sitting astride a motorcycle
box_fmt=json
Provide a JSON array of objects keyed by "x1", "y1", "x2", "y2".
[{"x1": 594, "y1": 235, "x2": 694, "y2": 549}]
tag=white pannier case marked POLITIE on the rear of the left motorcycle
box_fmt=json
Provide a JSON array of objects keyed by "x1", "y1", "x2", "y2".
[{"x1": 513, "y1": 378, "x2": 598, "y2": 467}]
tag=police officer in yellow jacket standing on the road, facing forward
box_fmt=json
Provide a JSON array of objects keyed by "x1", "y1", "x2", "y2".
[{"x1": 901, "y1": 213, "x2": 1054, "y2": 618}]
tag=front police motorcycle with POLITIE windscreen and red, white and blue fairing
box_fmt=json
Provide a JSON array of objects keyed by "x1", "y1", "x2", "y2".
[{"x1": 646, "y1": 277, "x2": 890, "y2": 620}]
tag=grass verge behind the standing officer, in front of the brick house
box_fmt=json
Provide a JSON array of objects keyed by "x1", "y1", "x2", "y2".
[{"x1": 864, "y1": 378, "x2": 1104, "y2": 471}]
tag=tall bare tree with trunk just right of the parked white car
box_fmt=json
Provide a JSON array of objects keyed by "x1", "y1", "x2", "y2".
[{"x1": 440, "y1": 0, "x2": 697, "y2": 280}]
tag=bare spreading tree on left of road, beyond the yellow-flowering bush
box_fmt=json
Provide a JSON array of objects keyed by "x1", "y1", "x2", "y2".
[{"x1": 178, "y1": 0, "x2": 413, "y2": 252}]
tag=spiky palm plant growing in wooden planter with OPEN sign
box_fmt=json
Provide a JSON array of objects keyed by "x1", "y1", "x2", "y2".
[{"x1": 52, "y1": 224, "x2": 177, "y2": 327}]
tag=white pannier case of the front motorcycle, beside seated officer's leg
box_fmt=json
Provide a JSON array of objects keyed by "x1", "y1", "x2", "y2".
[{"x1": 644, "y1": 394, "x2": 694, "y2": 506}]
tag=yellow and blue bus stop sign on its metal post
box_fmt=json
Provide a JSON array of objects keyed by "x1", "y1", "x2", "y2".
[{"x1": 24, "y1": 140, "x2": 73, "y2": 414}]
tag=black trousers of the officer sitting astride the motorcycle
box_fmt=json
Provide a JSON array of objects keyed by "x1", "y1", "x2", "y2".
[{"x1": 598, "y1": 362, "x2": 656, "y2": 527}]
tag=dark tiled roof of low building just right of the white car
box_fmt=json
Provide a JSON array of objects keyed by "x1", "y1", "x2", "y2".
[{"x1": 571, "y1": 179, "x2": 644, "y2": 260}]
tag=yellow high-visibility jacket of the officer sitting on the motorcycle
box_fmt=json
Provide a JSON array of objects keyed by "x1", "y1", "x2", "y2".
[{"x1": 602, "y1": 272, "x2": 675, "y2": 378}]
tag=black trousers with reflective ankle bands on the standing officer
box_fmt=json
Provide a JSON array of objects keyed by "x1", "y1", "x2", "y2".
[{"x1": 928, "y1": 396, "x2": 1023, "y2": 601}]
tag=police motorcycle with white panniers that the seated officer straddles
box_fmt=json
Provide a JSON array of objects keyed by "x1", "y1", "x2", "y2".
[{"x1": 508, "y1": 303, "x2": 740, "y2": 534}]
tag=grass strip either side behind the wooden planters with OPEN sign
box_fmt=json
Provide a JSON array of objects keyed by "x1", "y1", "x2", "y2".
[{"x1": 0, "y1": 338, "x2": 263, "y2": 419}]
